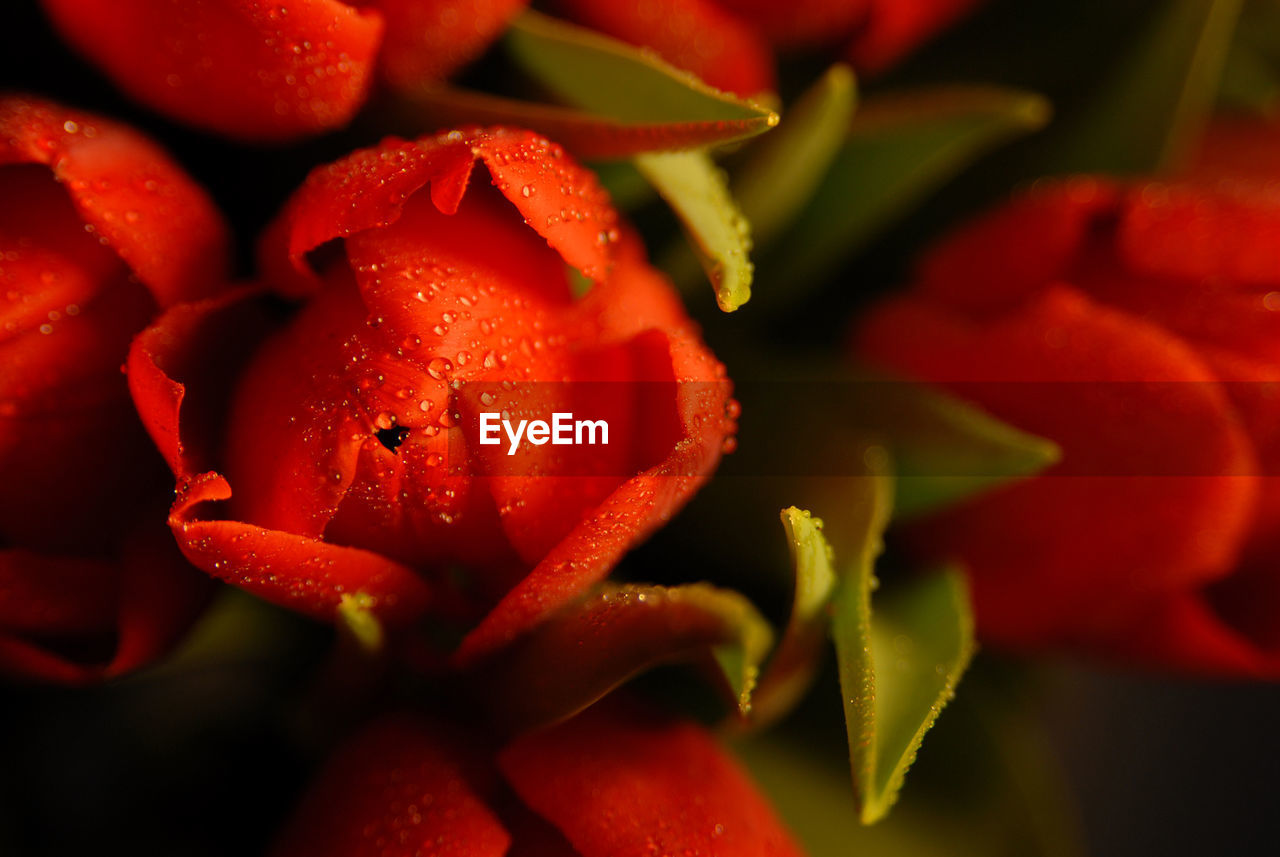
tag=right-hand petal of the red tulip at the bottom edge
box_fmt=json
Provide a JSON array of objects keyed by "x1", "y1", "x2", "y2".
[{"x1": 499, "y1": 706, "x2": 801, "y2": 857}]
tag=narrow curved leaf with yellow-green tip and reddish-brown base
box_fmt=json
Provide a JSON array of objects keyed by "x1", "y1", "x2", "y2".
[{"x1": 750, "y1": 507, "x2": 836, "y2": 729}]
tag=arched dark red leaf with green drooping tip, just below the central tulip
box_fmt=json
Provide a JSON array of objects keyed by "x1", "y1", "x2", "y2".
[{"x1": 474, "y1": 583, "x2": 773, "y2": 730}]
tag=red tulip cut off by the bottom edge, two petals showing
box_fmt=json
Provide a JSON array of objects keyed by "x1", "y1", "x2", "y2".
[{"x1": 273, "y1": 705, "x2": 801, "y2": 857}]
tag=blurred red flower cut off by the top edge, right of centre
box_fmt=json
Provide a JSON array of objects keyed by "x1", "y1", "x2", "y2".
[{"x1": 556, "y1": 0, "x2": 979, "y2": 97}]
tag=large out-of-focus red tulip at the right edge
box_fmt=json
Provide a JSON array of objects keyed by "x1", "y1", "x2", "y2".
[{"x1": 858, "y1": 159, "x2": 1280, "y2": 675}]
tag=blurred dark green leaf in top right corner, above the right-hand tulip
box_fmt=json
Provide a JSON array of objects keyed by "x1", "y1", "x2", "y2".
[{"x1": 1046, "y1": 0, "x2": 1242, "y2": 173}]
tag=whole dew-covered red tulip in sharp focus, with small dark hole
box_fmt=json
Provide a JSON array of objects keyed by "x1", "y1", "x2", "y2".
[{"x1": 129, "y1": 129, "x2": 733, "y2": 657}]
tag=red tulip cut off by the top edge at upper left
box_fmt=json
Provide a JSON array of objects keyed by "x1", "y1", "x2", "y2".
[{"x1": 44, "y1": 0, "x2": 527, "y2": 141}]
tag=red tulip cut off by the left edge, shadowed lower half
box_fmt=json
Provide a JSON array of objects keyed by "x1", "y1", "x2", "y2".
[{"x1": 0, "y1": 96, "x2": 227, "y2": 680}]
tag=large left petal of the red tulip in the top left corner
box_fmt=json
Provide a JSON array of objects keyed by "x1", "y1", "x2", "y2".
[{"x1": 44, "y1": 0, "x2": 383, "y2": 141}]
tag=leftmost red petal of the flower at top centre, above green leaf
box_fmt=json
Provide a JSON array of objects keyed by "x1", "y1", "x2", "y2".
[{"x1": 556, "y1": 0, "x2": 777, "y2": 97}]
